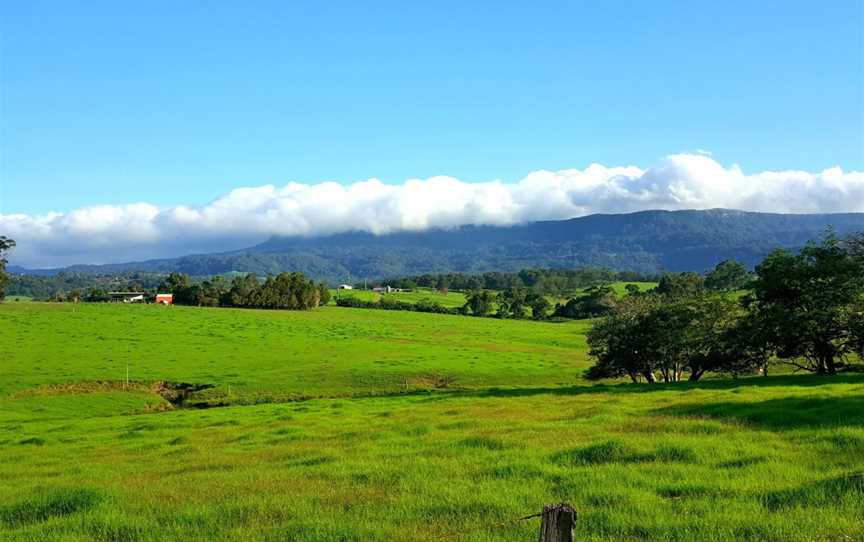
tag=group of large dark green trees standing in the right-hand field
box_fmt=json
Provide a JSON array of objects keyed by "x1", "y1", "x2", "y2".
[{"x1": 587, "y1": 233, "x2": 864, "y2": 382}]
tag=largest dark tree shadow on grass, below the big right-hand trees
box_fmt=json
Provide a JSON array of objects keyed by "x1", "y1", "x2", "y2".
[{"x1": 654, "y1": 396, "x2": 864, "y2": 431}]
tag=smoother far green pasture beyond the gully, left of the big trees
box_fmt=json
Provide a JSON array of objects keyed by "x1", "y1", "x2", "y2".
[{"x1": 0, "y1": 303, "x2": 587, "y2": 402}]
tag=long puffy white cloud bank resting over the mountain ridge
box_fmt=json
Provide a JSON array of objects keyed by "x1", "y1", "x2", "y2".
[{"x1": 0, "y1": 151, "x2": 864, "y2": 267}]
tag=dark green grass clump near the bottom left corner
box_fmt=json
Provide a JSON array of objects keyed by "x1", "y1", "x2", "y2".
[{"x1": 0, "y1": 488, "x2": 103, "y2": 528}]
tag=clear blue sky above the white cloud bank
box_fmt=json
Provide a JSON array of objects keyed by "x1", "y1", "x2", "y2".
[{"x1": 0, "y1": 0, "x2": 864, "y2": 215}]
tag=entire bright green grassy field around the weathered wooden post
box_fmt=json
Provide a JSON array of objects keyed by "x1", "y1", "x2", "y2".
[{"x1": 0, "y1": 303, "x2": 864, "y2": 541}]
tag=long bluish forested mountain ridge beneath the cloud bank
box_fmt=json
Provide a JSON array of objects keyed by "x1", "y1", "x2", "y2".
[{"x1": 10, "y1": 209, "x2": 864, "y2": 283}]
